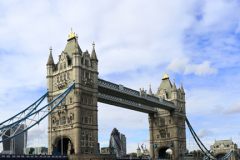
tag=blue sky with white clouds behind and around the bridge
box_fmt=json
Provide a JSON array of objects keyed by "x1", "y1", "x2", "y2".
[{"x1": 0, "y1": 0, "x2": 240, "y2": 155}]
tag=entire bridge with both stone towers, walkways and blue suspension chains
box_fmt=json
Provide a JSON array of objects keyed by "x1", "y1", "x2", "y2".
[{"x1": 0, "y1": 28, "x2": 237, "y2": 160}]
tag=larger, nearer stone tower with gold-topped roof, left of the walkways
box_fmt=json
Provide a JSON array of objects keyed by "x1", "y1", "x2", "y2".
[{"x1": 47, "y1": 31, "x2": 98, "y2": 154}]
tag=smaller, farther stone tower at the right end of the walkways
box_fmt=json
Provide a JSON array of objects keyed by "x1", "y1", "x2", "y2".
[{"x1": 149, "y1": 73, "x2": 186, "y2": 159}]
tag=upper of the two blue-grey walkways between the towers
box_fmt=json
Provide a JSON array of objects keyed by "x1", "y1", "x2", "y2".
[{"x1": 98, "y1": 78, "x2": 176, "y2": 109}]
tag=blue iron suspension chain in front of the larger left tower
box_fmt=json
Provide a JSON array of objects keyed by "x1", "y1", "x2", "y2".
[{"x1": 0, "y1": 82, "x2": 75, "y2": 143}]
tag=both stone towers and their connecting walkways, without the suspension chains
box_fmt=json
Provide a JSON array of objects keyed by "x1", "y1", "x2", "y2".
[{"x1": 47, "y1": 29, "x2": 186, "y2": 158}]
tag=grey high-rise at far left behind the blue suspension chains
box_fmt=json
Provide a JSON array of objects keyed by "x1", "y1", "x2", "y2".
[{"x1": 2, "y1": 124, "x2": 27, "y2": 154}]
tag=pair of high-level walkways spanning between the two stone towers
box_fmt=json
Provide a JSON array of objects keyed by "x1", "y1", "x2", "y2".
[{"x1": 98, "y1": 78, "x2": 176, "y2": 113}]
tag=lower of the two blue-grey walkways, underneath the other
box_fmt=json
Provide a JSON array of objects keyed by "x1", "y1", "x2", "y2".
[{"x1": 98, "y1": 92, "x2": 157, "y2": 113}]
